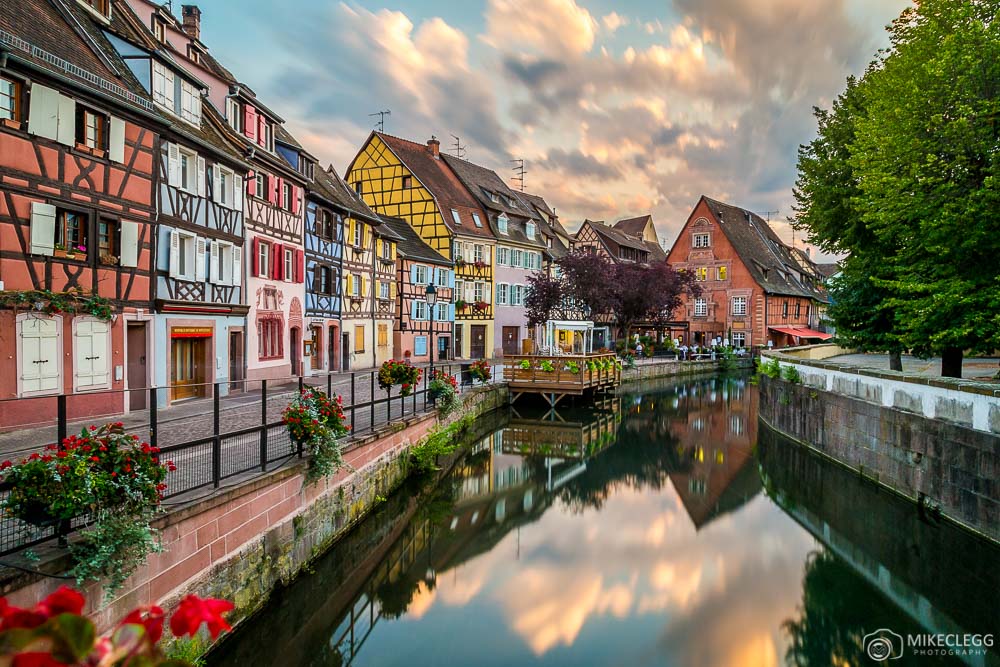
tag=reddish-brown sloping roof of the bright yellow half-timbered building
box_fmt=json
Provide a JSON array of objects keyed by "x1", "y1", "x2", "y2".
[{"x1": 372, "y1": 132, "x2": 494, "y2": 238}]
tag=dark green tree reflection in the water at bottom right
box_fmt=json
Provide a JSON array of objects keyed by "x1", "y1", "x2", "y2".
[{"x1": 782, "y1": 551, "x2": 960, "y2": 667}]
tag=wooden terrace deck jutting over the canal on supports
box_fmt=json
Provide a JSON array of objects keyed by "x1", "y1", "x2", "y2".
[{"x1": 503, "y1": 352, "x2": 622, "y2": 407}]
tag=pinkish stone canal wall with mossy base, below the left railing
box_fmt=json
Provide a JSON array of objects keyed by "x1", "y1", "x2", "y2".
[{"x1": 0, "y1": 385, "x2": 509, "y2": 630}]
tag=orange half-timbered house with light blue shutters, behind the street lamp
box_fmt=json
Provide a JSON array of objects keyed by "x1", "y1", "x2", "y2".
[{"x1": 382, "y1": 216, "x2": 455, "y2": 363}]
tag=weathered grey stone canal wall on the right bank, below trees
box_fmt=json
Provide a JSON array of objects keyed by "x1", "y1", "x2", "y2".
[{"x1": 760, "y1": 376, "x2": 1000, "y2": 540}]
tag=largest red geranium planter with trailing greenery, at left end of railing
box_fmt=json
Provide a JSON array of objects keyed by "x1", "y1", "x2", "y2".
[{"x1": 0, "y1": 422, "x2": 176, "y2": 597}]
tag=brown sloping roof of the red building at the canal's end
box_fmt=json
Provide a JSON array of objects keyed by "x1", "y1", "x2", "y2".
[{"x1": 702, "y1": 195, "x2": 826, "y2": 299}]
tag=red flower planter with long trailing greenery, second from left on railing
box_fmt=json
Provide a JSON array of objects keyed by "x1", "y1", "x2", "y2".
[{"x1": 281, "y1": 387, "x2": 351, "y2": 482}]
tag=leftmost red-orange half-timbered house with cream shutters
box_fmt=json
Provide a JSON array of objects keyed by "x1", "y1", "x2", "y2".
[{"x1": 0, "y1": 0, "x2": 163, "y2": 426}]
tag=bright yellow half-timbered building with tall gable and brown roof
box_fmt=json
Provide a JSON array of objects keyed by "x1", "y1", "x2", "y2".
[{"x1": 345, "y1": 132, "x2": 496, "y2": 360}]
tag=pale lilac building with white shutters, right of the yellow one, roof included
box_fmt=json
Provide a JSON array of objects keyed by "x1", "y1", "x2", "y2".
[{"x1": 443, "y1": 155, "x2": 547, "y2": 357}]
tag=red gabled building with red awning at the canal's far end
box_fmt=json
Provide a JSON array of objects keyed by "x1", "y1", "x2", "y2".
[{"x1": 667, "y1": 196, "x2": 830, "y2": 348}]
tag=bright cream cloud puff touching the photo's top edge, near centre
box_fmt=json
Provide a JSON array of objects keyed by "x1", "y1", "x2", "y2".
[{"x1": 483, "y1": 0, "x2": 597, "y2": 57}]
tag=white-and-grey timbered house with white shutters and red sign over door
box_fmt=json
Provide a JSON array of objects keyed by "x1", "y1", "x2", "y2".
[{"x1": 101, "y1": 3, "x2": 249, "y2": 403}]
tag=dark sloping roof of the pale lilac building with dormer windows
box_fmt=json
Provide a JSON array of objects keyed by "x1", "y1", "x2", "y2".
[{"x1": 442, "y1": 155, "x2": 545, "y2": 248}]
